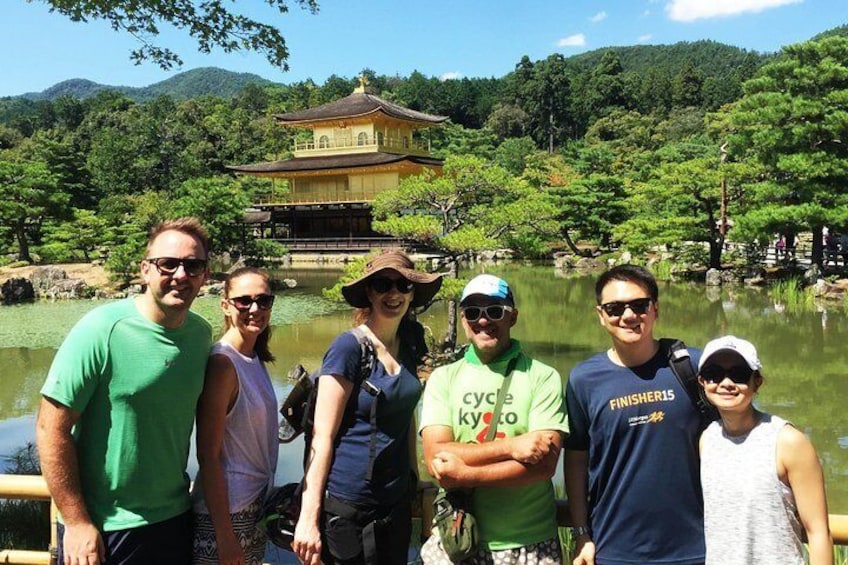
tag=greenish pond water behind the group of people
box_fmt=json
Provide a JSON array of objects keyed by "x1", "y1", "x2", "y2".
[{"x1": 0, "y1": 265, "x2": 848, "y2": 536}]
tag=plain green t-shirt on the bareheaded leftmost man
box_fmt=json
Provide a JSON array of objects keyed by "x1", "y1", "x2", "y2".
[{"x1": 41, "y1": 299, "x2": 212, "y2": 531}]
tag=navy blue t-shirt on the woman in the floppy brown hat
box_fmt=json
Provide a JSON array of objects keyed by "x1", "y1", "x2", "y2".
[{"x1": 321, "y1": 332, "x2": 421, "y2": 505}]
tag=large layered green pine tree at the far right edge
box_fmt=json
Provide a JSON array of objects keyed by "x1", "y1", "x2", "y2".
[{"x1": 714, "y1": 37, "x2": 848, "y2": 264}]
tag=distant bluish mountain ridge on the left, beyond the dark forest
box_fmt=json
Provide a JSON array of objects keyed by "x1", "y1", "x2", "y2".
[{"x1": 15, "y1": 67, "x2": 271, "y2": 102}]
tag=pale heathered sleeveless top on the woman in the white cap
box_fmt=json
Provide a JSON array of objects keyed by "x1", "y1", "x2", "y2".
[{"x1": 701, "y1": 414, "x2": 804, "y2": 565}]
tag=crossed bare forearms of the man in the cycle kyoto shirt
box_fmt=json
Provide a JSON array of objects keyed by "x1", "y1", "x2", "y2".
[{"x1": 421, "y1": 425, "x2": 562, "y2": 488}]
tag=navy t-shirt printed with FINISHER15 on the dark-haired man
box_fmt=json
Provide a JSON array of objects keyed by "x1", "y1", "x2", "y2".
[{"x1": 566, "y1": 348, "x2": 704, "y2": 565}]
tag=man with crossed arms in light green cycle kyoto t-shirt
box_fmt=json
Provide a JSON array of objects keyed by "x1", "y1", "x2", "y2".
[{"x1": 421, "y1": 275, "x2": 568, "y2": 565}]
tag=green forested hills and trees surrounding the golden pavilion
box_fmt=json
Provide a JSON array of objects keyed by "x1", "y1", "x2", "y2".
[{"x1": 0, "y1": 27, "x2": 848, "y2": 273}]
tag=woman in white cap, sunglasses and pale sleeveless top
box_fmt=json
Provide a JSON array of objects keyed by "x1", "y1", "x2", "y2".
[{"x1": 698, "y1": 336, "x2": 833, "y2": 565}]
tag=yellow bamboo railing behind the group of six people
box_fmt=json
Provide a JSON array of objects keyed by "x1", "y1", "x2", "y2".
[{"x1": 0, "y1": 474, "x2": 848, "y2": 565}]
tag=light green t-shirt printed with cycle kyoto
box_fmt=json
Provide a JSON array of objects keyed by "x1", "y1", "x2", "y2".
[{"x1": 420, "y1": 340, "x2": 568, "y2": 551}]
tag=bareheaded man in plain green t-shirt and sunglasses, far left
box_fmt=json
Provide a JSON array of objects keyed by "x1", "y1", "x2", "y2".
[{"x1": 36, "y1": 218, "x2": 212, "y2": 565}]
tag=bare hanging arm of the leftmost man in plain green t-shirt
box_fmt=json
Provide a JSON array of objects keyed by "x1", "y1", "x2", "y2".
[{"x1": 35, "y1": 396, "x2": 106, "y2": 565}]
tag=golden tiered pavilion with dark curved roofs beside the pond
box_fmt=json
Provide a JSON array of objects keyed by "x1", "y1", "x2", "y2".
[{"x1": 229, "y1": 81, "x2": 447, "y2": 251}]
